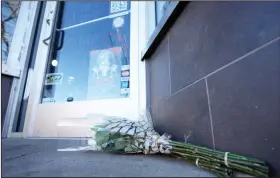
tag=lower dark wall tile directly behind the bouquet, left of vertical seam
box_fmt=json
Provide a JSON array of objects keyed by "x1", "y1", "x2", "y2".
[{"x1": 152, "y1": 81, "x2": 213, "y2": 148}]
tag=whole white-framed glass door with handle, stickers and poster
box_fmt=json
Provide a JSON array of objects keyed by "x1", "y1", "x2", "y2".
[{"x1": 3, "y1": 1, "x2": 150, "y2": 137}]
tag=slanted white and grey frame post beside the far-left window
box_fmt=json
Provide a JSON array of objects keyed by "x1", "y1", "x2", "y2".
[{"x1": 1, "y1": 1, "x2": 39, "y2": 137}]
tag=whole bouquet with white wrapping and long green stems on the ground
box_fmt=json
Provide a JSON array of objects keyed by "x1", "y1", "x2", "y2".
[{"x1": 57, "y1": 110, "x2": 269, "y2": 177}]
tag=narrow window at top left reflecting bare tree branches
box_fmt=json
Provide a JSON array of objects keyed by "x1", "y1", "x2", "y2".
[{"x1": 1, "y1": 0, "x2": 20, "y2": 63}]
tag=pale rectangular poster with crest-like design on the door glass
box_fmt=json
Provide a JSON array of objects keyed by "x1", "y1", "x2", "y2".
[{"x1": 87, "y1": 47, "x2": 123, "y2": 99}]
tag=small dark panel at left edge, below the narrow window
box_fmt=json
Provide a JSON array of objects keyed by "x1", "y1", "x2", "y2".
[{"x1": 1, "y1": 74, "x2": 13, "y2": 129}]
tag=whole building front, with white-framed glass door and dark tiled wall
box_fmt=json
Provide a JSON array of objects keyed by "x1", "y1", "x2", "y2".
[{"x1": 2, "y1": 1, "x2": 280, "y2": 176}]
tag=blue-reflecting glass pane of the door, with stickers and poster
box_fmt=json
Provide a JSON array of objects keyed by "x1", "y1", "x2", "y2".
[{"x1": 42, "y1": 1, "x2": 130, "y2": 103}]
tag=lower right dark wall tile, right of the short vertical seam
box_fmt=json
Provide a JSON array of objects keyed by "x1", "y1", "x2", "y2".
[{"x1": 208, "y1": 40, "x2": 280, "y2": 175}]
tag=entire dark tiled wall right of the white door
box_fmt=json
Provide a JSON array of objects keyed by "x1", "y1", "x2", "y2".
[{"x1": 147, "y1": 2, "x2": 280, "y2": 176}]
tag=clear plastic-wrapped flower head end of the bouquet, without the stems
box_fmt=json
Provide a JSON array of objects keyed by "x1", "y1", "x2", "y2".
[{"x1": 58, "y1": 111, "x2": 171, "y2": 154}]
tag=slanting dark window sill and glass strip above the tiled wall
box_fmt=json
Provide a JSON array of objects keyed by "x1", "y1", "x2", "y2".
[{"x1": 141, "y1": 1, "x2": 188, "y2": 61}]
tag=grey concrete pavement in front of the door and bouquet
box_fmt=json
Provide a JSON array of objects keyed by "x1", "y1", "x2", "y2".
[{"x1": 2, "y1": 139, "x2": 214, "y2": 177}]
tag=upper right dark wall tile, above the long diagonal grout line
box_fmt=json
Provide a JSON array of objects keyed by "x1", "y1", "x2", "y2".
[{"x1": 169, "y1": 2, "x2": 280, "y2": 93}]
